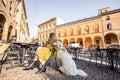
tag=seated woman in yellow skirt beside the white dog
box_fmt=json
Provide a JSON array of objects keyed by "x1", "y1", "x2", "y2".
[{"x1": 25, "y1": 33, "x2": 57, "y2": 73}]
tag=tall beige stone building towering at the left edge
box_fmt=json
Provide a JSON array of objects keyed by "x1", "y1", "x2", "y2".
[{"x1": 0, "y1": 0, "x2": 29, "y2": 42}]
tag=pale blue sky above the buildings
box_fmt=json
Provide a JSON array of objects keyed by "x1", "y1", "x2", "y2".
[{"x1": 24, "y1": 0, "x2": 120, "y2": 38}]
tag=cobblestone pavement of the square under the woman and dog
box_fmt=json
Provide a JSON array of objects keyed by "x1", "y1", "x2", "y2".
[{"x1": 0, "y1": 59, "x2": 120, "y2": 80}]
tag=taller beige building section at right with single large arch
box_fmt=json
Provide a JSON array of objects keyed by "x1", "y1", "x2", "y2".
[{"x1": 100, "y1": 8, "x2": 120, "y2": 47}]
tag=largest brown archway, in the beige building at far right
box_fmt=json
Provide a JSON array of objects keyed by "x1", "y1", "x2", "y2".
[{"x1": 104, "y1": 33, "x2": 119, "y2": 46}]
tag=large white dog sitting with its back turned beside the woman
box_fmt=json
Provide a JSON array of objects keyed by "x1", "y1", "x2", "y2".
[{"x1": 53, "y1": 41, "x2": 87, "y2": 77}]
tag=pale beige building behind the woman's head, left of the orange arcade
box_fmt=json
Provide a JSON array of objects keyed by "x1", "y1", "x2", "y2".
[{"x1": 38, "y1": 18, "x2": 64, "y2": 46}]
